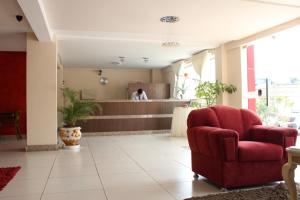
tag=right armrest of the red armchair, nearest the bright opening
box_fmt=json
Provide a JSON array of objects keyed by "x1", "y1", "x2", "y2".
[{"x1": 249, "y1": 125, "x2": 298, "y2": 149}]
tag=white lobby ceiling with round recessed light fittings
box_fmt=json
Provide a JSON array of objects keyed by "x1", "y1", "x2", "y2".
[{"x1": 15, "y1": 0, "x2": 300, "y2": 68}]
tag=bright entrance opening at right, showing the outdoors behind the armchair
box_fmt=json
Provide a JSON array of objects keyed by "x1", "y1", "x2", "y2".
[{"x1": 247, "y1": 26, "x2": 300, "y2": 130}]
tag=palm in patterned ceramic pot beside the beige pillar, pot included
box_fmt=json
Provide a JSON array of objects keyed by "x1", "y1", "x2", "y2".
[{"x1": 58, "y1": 88, "x2": 96, "y2": 148}]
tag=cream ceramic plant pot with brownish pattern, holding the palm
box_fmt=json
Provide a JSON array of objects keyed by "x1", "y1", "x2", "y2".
[{"x1": 59, "y1": 127, "x2": 81, "y2": 147}]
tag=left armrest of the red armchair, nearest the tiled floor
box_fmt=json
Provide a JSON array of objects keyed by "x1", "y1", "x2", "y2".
[{"x1": 188, "y1": 126, "x2": 239, "y2": 161}]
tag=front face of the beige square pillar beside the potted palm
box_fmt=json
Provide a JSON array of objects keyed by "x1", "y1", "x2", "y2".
[{"x1": 26, "y1": 33, "x2": 57, "y2": 146}]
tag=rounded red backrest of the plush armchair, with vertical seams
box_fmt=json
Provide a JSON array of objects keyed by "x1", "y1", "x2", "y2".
[{"x1": 188, "y1": 106, "x2": 262, "y2": 140}]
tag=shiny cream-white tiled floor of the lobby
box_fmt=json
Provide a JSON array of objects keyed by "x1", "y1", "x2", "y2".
[{"x1": 0, "y1": 134, "x2": 298, "y2": 200}]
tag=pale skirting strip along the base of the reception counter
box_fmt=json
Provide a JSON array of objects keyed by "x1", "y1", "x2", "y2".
[{"x1": 82, "y1": 129, "x2": 171, "y2": 136}]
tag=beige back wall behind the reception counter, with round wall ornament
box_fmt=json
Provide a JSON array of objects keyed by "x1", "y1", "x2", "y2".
[{"x1": 63, "y1": 67, "x2": 151, "y2": 100}]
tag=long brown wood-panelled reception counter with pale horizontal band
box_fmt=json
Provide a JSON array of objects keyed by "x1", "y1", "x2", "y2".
[{"x1": 78, "y1": 99, "x2": 189, "y2": 133}]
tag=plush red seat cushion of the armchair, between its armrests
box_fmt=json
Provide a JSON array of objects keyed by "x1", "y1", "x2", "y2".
[{"x1": 238, "y1": 141, "x2": 283, "y2": 162}]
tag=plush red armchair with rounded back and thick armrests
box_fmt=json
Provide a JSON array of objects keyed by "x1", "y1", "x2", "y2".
[{"x1": 187, "y1": 106, "x2": 297, "y2": 188}]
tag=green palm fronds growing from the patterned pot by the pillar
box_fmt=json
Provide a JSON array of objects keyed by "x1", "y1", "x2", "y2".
[{"x1": 58, "y1": 88, "x2": 96, "y2": 127}]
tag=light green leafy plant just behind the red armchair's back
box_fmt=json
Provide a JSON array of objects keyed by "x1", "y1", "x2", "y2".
[{"x1": 196, "y1": 81, "x2": 237, "y2": 107}]
